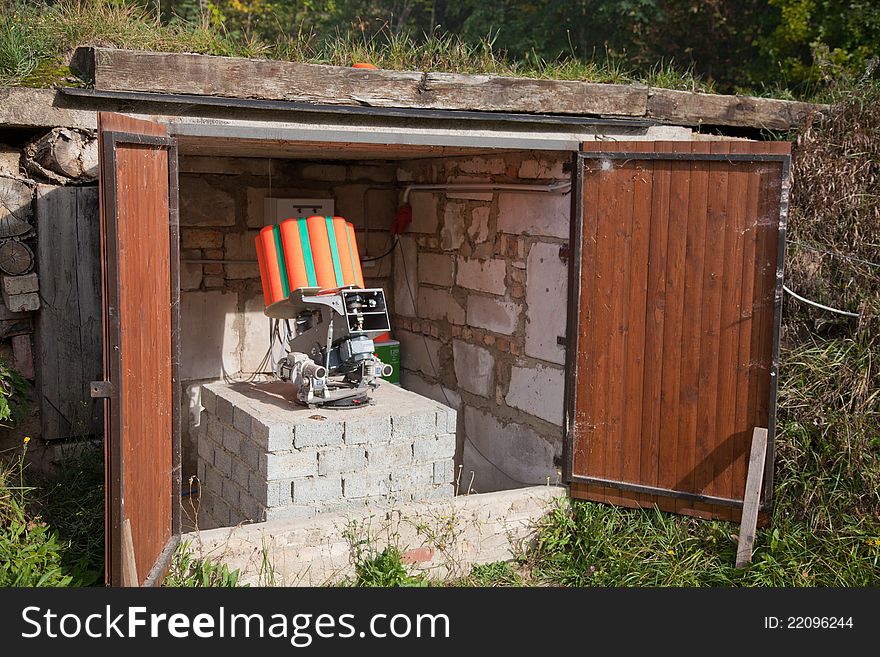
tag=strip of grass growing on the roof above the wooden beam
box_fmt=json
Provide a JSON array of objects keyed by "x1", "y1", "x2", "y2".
[{"x1": 0, "y1": 0, "x2": 712, "y2": 91}]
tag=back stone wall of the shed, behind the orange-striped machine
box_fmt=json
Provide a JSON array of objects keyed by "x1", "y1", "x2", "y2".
[{"x1": 180, "y1": 156, "x2": 397, "y2": 479}]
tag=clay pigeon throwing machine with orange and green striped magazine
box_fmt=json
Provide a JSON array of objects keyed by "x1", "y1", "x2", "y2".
[{"x1": 256, "y1": 216, "x2": 392, "y2": 407}]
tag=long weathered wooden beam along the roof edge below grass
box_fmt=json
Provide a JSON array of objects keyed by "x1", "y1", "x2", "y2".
[{"x1": 71, "y1": 48, "x2": 821, "y2": 130}]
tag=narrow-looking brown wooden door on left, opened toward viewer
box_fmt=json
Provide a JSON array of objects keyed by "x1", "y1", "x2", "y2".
[{"x1": 94, "y1": 113, "x2": 180, "y2": 586}]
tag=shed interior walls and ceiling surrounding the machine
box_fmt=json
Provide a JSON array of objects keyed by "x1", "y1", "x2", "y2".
[{"x1": 177, "y1": 135, "x2": 572, "y2": 500}]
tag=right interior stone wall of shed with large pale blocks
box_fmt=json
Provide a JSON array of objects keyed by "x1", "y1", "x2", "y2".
[{"x1": 392, "y1": 153, "x2": 571, "y2": 492}]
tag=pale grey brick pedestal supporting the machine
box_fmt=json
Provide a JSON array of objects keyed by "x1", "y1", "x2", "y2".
[{"x1": 196, "y1": 382, "x2": 456, "y2": 528}]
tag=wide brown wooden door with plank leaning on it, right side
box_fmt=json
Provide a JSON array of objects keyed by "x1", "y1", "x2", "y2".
[{"x1": 565, "y1": 141, "x2": 790, "y2": 519}]
